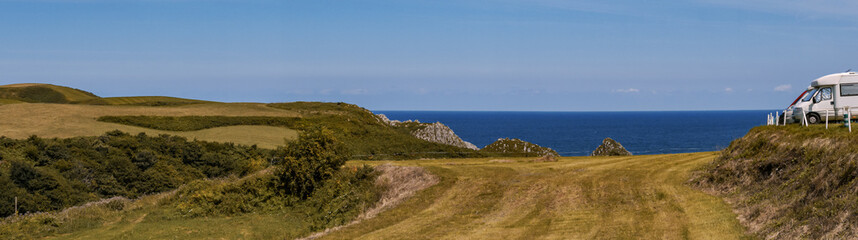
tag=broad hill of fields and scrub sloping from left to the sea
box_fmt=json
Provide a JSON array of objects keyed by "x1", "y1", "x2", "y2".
[{"x1": 0, "y1": 84, "x2": 481, "y2": 159}]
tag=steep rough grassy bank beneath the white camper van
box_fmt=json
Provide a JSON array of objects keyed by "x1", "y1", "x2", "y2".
[{"x1": 691, "y1": 125, "x2": 858, "y2": 239}]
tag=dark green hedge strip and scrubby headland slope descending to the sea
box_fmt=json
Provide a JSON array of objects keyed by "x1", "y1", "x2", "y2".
[{"x1": 98, "y1": 102, "x2": 482, "y2": 159}]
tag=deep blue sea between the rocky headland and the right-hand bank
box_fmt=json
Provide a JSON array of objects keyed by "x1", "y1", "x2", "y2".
[{"x1": 375, "y1": 110, "x2": 773, "y2": 156}]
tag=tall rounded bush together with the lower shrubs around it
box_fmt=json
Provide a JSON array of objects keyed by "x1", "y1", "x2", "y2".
[{"x1": 171, "y1": 128, "x2": 381, "y2": 228}]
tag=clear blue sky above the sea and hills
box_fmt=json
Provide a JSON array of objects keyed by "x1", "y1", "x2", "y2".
[{"x1": 0, "y1": 0, "x2": 858, "y2": 111}]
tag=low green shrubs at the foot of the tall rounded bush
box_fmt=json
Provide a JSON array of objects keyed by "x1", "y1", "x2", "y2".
[{"x1": 167, "y1": 166, "x2": 382, "y2": 228}]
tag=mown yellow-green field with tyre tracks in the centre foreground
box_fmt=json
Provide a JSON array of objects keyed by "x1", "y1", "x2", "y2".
[{"x1": 320, "y1": 152, "x2": 744, "y2": 239}]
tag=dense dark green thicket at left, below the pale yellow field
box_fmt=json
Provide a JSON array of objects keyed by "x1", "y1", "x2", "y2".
[{"x1": 0, "y1": 131, "x2": 275, "y2": 217}]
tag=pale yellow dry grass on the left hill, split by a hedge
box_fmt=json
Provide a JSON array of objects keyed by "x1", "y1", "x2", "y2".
[{"x1": 0, "y1": 103, "x2": 298, "y2": 148}]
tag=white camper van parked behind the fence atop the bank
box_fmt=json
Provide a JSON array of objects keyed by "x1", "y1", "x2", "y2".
[{"x1": 785, "y1": 72, "x2": 858, "y2": 124}]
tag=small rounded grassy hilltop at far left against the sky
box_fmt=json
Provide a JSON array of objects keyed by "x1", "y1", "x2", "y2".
[{"x1": 0, "y1": 83, "x2": 99, "y2": 103}]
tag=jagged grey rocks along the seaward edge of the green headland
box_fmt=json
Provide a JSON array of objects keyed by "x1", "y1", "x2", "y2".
[{"x1": 376, "y1": 114, "x2": 480, "y2": 150}]
